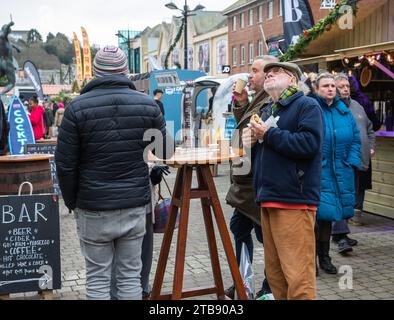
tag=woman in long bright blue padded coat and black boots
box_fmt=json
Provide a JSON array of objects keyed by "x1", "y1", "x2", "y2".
[{"x1": 316, "y1": 73, "x2": 361, "y2": 274}]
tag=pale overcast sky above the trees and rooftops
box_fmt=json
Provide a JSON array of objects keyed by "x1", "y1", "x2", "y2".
[{"x1": 0, "y1": 0, "x2": 236, "y2": 46}]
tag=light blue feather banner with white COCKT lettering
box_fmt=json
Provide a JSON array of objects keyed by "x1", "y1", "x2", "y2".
[{"x1": 8, "y1": 96, "x2": 36, "y2": 155}]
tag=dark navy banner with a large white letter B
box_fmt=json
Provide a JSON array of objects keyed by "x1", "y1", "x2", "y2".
[{"x1": 281, "y1": 0, "x2": 314, "y2": 50}]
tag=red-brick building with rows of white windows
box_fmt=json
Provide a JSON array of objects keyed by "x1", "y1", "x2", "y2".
[{"x1": 223, "y1": 0, "x2": 335, "y2": 74}]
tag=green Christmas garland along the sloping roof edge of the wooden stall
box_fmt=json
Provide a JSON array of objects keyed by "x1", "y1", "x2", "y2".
[{"x1": 280, "y1": 0, "x2": 358, "y2": 62}]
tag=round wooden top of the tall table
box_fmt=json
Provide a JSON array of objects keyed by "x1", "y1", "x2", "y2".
[{"x1": 149, "y1": 148, "x2": 244, "y2": 167}]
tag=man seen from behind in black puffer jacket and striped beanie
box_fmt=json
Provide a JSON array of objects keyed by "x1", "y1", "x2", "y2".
[{"x1": 55, "y1": 47, "x2": 172, "y2": 300}]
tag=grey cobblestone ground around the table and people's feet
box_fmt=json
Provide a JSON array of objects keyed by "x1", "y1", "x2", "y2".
[{"x1": 11, "y1": 165, "x2": 394, "y2": 300}]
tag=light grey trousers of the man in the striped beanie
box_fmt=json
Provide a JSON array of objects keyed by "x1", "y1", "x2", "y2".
[{"x1": 75, "y1": 206, "x2": 146, "y2": 300}]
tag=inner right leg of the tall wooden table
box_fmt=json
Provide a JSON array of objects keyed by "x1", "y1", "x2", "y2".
[{"x1": 197, "y1": 167, "x2": 226, "y2": 300}]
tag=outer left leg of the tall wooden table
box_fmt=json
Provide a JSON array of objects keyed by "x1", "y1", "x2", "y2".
[{"x1": 150, "y1": 168, "x2": 184, "y2": 300}]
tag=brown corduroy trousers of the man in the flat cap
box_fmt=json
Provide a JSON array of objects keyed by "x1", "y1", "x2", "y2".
[{"x1": 261, "y1": 208, "x2": 316, "y2": 300}]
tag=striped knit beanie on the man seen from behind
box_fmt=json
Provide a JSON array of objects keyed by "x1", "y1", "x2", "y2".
[{"x1": 93, "y1": 46, "x2": 129, "y2": 77}]
